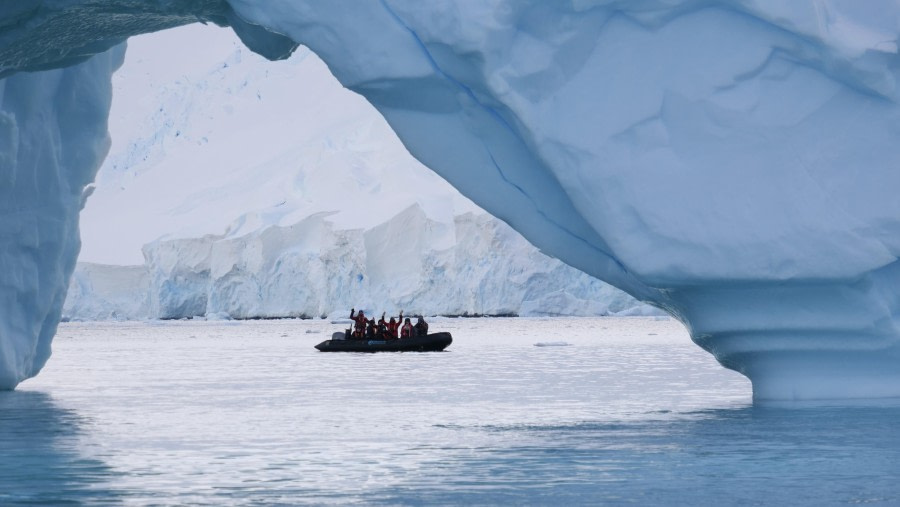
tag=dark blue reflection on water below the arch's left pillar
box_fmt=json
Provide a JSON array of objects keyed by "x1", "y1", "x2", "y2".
[{"x1": 0, "y1": 391, "x2": 118, "y2": 505}]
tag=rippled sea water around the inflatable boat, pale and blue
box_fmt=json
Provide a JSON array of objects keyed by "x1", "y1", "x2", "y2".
[{"x1": 0, "y1": 318, "x2": 900, "y2": 505}]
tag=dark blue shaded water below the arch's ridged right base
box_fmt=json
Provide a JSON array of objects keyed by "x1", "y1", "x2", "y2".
[{"x1": 379, "y1": 405, "x2": 900, "y2": 505}]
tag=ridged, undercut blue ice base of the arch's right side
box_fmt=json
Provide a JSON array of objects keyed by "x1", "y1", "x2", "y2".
[{"x1": 672, "y1": 262, "x2": 900, "y2": 400}]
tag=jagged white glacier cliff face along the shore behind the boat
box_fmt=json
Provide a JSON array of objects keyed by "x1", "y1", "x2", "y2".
[{"x1": 63, "y1": 205, "x2": 658, "y2": 320}]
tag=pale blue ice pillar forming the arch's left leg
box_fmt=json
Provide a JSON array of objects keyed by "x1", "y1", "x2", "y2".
[{"x1": 0, "y1": 48, "x2": 124, "y2": 388}]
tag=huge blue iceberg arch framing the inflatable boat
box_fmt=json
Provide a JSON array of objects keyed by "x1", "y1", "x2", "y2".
[{"x1": 0, "y1": 0, "x2": 900, "y2": 399}]
